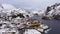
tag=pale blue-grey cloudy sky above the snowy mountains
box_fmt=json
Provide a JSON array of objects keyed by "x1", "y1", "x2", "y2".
[{"x1": 0, "y1": 0, "x2": 60, "y2": 10}]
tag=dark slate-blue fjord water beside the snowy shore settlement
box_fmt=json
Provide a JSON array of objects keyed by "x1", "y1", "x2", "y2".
[{"x1": 32, "y1": 16, "x2": 60, "y2": 34}]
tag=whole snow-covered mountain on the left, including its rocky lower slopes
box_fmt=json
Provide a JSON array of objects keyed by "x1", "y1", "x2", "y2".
[{"x1": 0, "y1": 4, "x2": 28, "y2": 17}]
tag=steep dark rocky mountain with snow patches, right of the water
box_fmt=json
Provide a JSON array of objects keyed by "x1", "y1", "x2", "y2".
[{"x1": 44, "y1": 3, "x2": 60, "y2": 19}]
